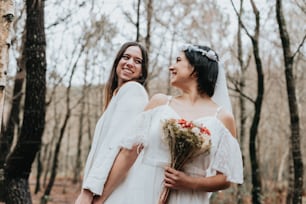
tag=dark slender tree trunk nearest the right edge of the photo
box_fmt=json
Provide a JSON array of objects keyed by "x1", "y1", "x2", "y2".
[{"x1": 276, "y1": 0, "x2": 303, "y2": 204}]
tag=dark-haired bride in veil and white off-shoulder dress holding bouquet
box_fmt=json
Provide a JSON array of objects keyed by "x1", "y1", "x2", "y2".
[{"x1": 93, "y1": 45, "x2": 243, "y2": 204}]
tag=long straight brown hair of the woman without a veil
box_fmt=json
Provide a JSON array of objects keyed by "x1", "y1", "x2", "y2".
[{"x1": 103, "y1": 42, "x2": 149, "y2": 111}]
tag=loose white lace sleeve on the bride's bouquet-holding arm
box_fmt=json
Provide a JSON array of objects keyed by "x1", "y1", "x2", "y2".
[{"x1": 210, "y1": 128, "x2": 243, "y2": 184}]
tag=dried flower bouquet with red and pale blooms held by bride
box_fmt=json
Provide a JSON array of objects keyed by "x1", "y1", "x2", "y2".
[{"x1": 160, "y1": 119, "x2": 211, "y2": 203}]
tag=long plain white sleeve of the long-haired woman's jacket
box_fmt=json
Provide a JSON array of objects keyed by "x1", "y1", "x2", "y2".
[{"x1": 82, "y1": 82, "x2": 148, "y2": 195}]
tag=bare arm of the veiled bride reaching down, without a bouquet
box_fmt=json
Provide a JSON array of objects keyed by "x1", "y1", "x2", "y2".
[{"x1": 93, "y1": 145, "x2": 141, "y2": 204}]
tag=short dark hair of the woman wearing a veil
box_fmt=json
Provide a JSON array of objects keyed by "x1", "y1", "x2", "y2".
[{"x1": 183, "y1": 45, "x2": 219, "y2": 97}]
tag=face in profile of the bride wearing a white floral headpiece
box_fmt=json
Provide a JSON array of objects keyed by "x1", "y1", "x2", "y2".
[{"x1": 169, "y1": 52, "x2": 194, "y2": 87}]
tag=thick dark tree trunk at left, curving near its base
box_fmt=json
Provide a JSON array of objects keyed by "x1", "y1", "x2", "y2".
[{"x1": 5, "y1": 0, "x2": 46, "y2": 204}]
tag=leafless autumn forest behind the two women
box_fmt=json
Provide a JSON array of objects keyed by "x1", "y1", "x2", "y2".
[{"x1": 0, "y1": 0, "x2": 306, "y2": 204}]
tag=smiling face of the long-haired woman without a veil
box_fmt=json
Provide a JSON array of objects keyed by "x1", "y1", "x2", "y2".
[{"x1": 116, "y1": 46, "x2": 143, "y2": 86}]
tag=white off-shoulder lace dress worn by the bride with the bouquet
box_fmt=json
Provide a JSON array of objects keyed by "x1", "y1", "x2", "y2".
[{"x1": 105, "y1": 104, "x2": 243, "y2": 204}]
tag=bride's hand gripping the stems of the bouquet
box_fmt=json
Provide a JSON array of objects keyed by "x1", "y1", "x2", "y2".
[{"x1": 164, "y1": 167, "x2": 195, "y2": 190}]
